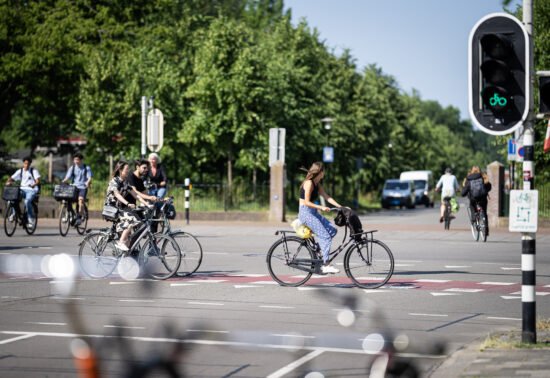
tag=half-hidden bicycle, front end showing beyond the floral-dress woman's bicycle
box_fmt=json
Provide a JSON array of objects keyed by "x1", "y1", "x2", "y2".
[{"x1": 154, "y1": 197, "x2": 202, "y2": 277}]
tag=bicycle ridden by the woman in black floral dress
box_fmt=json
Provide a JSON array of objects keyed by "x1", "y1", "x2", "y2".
[{"x1": 78, "y1": 207, "x2": 181, "y2": 280}]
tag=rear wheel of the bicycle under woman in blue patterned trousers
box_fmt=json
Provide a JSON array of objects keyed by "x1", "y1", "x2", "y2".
[{"x1": 266, "y1": 236, "x2": 315, "y2": 286}]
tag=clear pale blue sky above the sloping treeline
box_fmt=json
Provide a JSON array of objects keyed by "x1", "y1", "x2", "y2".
[{"x1": 285, "y1": 0, "x2": 521, "y2": 119}]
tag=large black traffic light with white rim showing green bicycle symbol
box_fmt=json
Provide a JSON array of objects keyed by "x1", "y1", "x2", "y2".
[{"x1": 468, "y1": 13, "x2": 530, "y2": 135}]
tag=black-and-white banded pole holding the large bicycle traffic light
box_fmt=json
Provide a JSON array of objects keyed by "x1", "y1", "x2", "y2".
[{"x1": 521, "y1": 0, "x2": 537, "y2": 344}]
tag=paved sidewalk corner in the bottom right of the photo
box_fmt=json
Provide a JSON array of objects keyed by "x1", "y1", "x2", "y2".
[{"x1": 429, "y1": 331, "x2": 550, "y2": 378}]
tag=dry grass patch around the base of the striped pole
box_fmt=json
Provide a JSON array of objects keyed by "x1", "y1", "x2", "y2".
[{"x1": 480, "y1": 319, "x2": 550, "y2": 351}]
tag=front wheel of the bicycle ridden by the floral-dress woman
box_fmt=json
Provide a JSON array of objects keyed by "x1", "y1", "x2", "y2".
[{"x1": 138, "y1": 234, "x2": 181, "y2": 280}]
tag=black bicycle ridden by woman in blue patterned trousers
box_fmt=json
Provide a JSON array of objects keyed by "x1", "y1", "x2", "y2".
[{"x1": 266, "y1": 209, "x2": 394, "y2": 289}]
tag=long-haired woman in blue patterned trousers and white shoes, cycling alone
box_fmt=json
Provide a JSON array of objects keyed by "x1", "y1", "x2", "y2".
[{"x1": 298, "y1": 162, "x2": 341, "y2": 273}]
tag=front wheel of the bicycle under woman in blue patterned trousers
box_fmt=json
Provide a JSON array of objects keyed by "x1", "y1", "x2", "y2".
[{"x1": 344, "y1": 240, "x2": 394, "y2": 289}]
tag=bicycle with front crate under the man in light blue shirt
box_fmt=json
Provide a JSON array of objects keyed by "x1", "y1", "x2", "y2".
[{"x1": 53, "y1": 185, "x2": 88, "y2": 236}]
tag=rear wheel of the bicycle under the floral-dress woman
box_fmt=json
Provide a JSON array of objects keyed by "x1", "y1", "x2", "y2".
[{"x1": 78, "y1": 231, "x2": 121, "y2": 278}]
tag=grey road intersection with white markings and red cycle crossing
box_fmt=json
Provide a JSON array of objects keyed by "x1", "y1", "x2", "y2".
[{"x1": 0, "y1": 208, "x2": 550, "y2": 377}]
